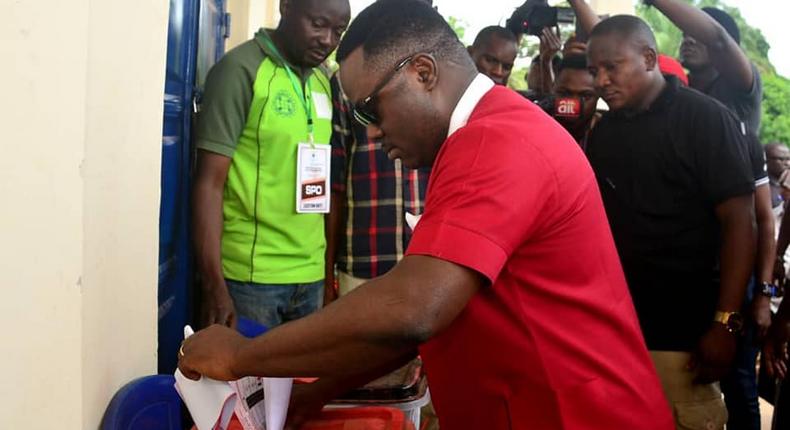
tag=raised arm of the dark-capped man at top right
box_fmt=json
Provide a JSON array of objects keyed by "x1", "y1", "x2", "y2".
[{"x1": 653, "y1": 0, "x2": 754, "y2": 92}]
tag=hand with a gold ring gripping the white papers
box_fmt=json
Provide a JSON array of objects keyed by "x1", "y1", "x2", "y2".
[{"x1": 178, "y1": 324, "x2": 249, "y2": 381}]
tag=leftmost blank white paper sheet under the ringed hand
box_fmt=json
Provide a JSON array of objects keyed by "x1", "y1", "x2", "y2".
[{"x1": 175, "y1": 326, "x2": 236, "y2": 430}]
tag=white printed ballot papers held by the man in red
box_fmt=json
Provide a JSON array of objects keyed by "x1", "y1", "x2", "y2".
[{"x1": 175, "y1": 326, "x2": 293, "y2": 430}]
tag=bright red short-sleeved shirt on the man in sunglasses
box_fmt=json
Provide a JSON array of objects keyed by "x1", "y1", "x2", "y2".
[{"x1": 408, "y1": 87, "x2": 675, "y2": 430}]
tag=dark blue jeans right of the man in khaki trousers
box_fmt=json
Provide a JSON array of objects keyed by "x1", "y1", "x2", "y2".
[{"x1": 721, "y1": 278, "x2": 760, "y2": 430}]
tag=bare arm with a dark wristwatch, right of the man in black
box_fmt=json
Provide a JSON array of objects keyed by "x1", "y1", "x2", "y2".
[{"x1": 751, "y1": 184, "x2": 776, "y2": 338}]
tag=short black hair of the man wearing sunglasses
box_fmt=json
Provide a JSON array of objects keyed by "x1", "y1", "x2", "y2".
[{"x1": 336, "y1": 0, "x2": 475, "y2": 68}]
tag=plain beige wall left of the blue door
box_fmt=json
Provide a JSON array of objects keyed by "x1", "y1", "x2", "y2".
[{"x1": 0, "y1": 0, "x2": 168, "y2": 430}]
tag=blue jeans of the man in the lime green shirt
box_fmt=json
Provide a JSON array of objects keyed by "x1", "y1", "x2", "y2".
[{"x1": 225, "y1": 279, "x2": 324, "y2": 328}]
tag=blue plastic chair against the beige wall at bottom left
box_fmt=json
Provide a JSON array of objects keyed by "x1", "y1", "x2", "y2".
[{"x1": 101, "y1": 375, "x2": 181, "y2": 430}]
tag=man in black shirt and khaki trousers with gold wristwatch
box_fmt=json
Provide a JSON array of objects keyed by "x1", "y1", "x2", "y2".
[{"x1": 588, "y1": 16, "x2": 756, "y2": 429}]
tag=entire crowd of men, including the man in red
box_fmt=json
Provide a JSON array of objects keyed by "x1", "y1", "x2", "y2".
[{"x1": 179, "y1": 0, "x2": 790, "y2": 430}]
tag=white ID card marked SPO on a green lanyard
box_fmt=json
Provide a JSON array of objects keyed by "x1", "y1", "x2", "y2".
[{"x1": 267, "y1": 33, "x2": 332, "y2": 214}]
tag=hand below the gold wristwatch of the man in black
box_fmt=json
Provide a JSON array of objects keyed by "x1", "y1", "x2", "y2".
[{"x1": 689, "y1": 323, "x2": 736, "y2": 384}]
